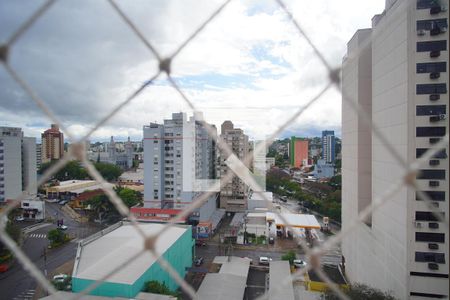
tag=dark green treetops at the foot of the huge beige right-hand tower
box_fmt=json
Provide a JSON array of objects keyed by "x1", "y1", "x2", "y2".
[{"x1": 323, "y1": 283, "x2": 396, "y2": 300}]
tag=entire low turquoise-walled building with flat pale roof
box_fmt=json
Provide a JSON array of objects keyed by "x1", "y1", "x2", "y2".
[{"x1": 72, "y1": 222, "x2": 195, "y2": 298}]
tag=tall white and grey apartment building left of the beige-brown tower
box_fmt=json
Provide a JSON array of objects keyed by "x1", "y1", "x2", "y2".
[{"x1": 143, "y1": 113, "x2": 218, "y2": 221}]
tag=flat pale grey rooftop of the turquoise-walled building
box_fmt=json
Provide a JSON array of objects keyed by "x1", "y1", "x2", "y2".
[{"x1": 73, "y1": 223, "x2": 187, "y2": 284}]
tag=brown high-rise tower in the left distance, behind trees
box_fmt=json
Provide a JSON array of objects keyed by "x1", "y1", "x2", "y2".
[{"x1": 41, "y1": 124, "x2": 64, "y2": 163}]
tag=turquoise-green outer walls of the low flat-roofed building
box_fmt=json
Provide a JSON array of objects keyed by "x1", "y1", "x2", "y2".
[{"x1": 72, "y1": 226, "x2": 194, "y2": 298}]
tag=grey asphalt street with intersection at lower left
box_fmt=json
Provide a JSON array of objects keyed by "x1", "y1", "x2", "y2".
[{"x1": 0, "y1": 203, "x2": 100, "y2": 300}]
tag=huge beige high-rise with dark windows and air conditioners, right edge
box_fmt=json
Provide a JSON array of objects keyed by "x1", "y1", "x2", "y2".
[{"x1": 342, "y1": 0, "x2": 449, "y2": 299}]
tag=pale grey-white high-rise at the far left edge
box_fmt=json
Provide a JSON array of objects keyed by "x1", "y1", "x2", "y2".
[{"x1": 0, "y1": 127, "x2": 37, "y2": 202}]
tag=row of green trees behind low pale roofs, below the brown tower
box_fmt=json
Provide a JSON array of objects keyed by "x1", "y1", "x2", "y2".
[{"x1": 39, "y1": 160, "x2": 123, "y2": 181}]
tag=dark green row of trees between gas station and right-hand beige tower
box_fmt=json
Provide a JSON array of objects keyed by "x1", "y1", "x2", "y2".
[{"x1": 266, "y1": 169, "x2": 341, "y2": 222}]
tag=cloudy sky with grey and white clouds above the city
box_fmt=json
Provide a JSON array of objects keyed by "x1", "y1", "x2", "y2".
[{"x1": 0, "y1": 0, "x2": 384, "y2": 141}]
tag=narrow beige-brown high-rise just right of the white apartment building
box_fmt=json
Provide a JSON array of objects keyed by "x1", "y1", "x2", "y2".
[{"x1": 220, "y1": 121, "x2": 249, "y2": 212}]
